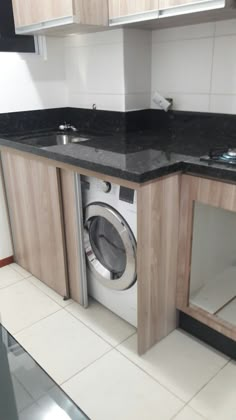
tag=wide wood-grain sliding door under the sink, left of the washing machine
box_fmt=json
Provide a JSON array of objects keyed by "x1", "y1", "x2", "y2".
[{"x1": 2, "y1": 152, "x2": 68, "y2": 296}]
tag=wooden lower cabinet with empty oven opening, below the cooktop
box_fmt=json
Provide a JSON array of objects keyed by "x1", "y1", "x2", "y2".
[{"x1": 177, "y1": 175, "x2": 236, "y2": 340}]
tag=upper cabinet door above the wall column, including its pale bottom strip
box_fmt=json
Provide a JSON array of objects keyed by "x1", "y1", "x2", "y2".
[{"x1": 109, "y1": 0, "x2": 159, "y2": 24}]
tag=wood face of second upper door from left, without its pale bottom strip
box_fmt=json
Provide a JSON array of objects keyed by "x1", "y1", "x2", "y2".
[{"x1": 109, "y1": 0, "x2": 159, "y2": 19}]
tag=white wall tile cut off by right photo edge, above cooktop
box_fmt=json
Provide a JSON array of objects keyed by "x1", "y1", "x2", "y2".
[{"x1": 212, "y1": 35, "x2": 236, "y2": 94}]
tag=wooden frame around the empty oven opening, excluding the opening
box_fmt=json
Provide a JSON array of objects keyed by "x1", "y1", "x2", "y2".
[{"x1": 177, "y1": 175, "x2": 236, "y2": 340}]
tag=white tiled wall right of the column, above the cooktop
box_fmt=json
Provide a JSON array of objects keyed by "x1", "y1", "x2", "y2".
[{"x1": 151, "y1": 20, "x2": 236, "y2": 114}]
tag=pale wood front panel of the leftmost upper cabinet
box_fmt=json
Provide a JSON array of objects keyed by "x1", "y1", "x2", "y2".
[{"x1": 13, "y1": 0, "x2": 73, "y2": 27}]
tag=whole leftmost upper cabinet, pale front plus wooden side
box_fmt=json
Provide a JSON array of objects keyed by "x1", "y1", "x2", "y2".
[{"x1": 13, "y1": 0, "x2": 108, "y2": 34}]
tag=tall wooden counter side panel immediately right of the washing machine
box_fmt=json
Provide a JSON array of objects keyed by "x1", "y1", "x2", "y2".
[{"x1": 138, "y1": 175, "x2": 180, "y2": 354}]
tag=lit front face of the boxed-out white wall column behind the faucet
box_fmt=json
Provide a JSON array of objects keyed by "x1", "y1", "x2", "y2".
[{"x1": 63, "y1": 29, "x2": 125, "y2": 111}]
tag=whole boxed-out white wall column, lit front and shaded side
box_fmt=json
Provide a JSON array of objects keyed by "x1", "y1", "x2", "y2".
[{"x1": 65, "y1": 29, "x2": 151, "y2": 111}]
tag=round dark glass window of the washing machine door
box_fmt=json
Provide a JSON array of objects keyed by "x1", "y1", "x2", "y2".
[{"x1": 89, "y1": 217, "x2": 126, "y2": 280}]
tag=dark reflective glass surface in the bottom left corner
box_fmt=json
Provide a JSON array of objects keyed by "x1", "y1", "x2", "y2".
[{"x1": 0, "y1": 325, "x2": 88, "y2": 420}]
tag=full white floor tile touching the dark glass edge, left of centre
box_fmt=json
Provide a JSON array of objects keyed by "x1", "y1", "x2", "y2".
[{"x1": 16, "y1": 309, "x2": 111, "y2": 384}]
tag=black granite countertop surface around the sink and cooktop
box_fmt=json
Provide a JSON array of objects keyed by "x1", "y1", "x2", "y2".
[{"x1": 0, "y1": 110, "x2": 236, "y2": 183}]
